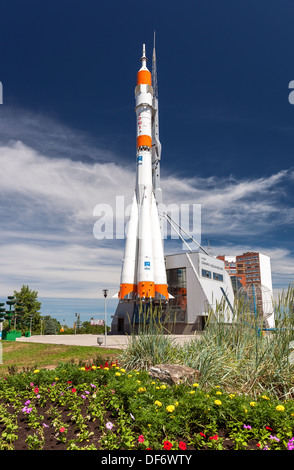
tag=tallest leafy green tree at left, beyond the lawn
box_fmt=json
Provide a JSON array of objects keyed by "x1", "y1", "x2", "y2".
[{"x1": 14, "y1": 285, "x2": 42, "y2": 332}]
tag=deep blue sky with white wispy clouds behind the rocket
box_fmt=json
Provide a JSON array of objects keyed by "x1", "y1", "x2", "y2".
[{"x1": 0, "y1": 0, "x2": 294, "y2": 324}]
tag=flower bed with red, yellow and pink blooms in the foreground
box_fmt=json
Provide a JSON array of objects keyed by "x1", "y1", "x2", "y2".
[{"x1": 0, "y1": 363, "x2": 294, "y2": 451}]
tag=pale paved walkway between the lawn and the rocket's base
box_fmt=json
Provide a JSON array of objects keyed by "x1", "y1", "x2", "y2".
[{"x1": 16, "y1": 335, "x2": 200, "y2": 349}]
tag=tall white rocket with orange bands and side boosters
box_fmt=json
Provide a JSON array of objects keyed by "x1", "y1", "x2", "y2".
[{"x1": 118, "y1": 45, "x2": 169, "y2": 301}]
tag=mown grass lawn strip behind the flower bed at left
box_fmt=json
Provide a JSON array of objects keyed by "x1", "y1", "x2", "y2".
[{"x1": 0, "y1": 341, "x2": 121, "y2": 378}]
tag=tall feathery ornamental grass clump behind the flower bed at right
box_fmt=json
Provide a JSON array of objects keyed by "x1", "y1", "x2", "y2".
[{"x1": 119, "y1": 286, "x2": 294, "y2": 398}]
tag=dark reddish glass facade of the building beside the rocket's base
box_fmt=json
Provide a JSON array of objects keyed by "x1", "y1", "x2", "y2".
[{"x1": 166, "y1": 268, "x2": 187, "y2": 323}]
